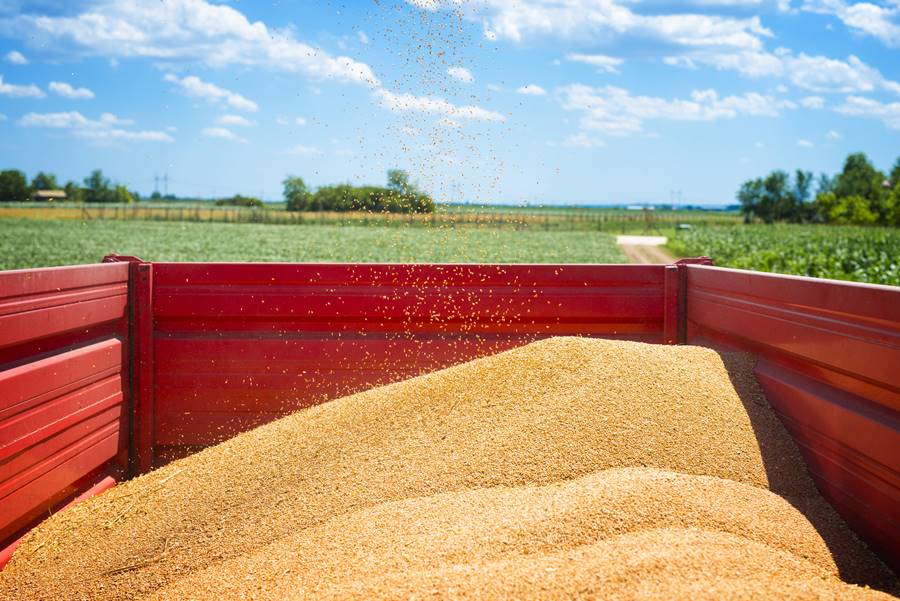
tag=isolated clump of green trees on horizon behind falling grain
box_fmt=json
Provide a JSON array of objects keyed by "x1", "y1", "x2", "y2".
[{"x1": 283, "y1": 169, "x2": 434, "y2": 213}]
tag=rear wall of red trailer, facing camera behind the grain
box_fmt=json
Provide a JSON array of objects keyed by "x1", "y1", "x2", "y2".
[{"x1": 149, "y1": 263, "x2": 674, "y2": 458}]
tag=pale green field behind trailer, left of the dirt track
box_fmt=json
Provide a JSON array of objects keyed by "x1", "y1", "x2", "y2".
[{"x1": 0, "y1": 219, "x2": 625, "y2": 269}]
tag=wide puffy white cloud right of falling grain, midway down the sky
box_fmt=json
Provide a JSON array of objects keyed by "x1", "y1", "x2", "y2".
[{"x1": 561, "y1": 84, "x2": 795, "y2": 135}]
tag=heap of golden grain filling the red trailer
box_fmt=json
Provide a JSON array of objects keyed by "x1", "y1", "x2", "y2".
[{"x1": 0, "y1": 338, "x2": 897, "y2": 601}]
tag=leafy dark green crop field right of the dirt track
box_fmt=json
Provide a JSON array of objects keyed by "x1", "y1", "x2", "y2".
[{"x1": 669, "y1": 225, "x2": 900, "y2": 286}]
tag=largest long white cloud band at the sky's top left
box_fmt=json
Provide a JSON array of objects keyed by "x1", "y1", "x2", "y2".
[{"x1": 3, "y1": 0, "x2": 378, "y2": 86}]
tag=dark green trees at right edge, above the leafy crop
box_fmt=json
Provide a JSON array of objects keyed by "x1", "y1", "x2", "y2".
[{"x1": 737, "y1": 152, "x2": 900, "y2": 226}]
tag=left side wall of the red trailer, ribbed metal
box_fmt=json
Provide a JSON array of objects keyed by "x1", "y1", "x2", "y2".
[{"x1": 0, "y1": 264, "x2": 128, "y2": 548}]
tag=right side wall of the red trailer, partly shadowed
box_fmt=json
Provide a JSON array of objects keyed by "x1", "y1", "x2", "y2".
[{"x1": 687, "y1": 266, "x2": 900, "y2": 569}]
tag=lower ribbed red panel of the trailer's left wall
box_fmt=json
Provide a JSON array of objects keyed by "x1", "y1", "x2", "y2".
[{"x1": 0, "y1": 339, "x2": 124, "y2": 541}]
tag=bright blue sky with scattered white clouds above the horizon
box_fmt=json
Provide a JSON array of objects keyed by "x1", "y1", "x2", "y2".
[{"x1": 0, "y1": 0, "x2": 900, "y2": 204}]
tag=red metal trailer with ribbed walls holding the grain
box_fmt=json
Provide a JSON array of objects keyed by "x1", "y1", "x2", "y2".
[{"x1": 0, "y1": 256, "x2": 900, "y2": 570}]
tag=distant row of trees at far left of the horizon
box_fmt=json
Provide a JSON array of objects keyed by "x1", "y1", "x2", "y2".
[{"x1": 0, "y1": 169, "x2": 140, "y2": 204}]
